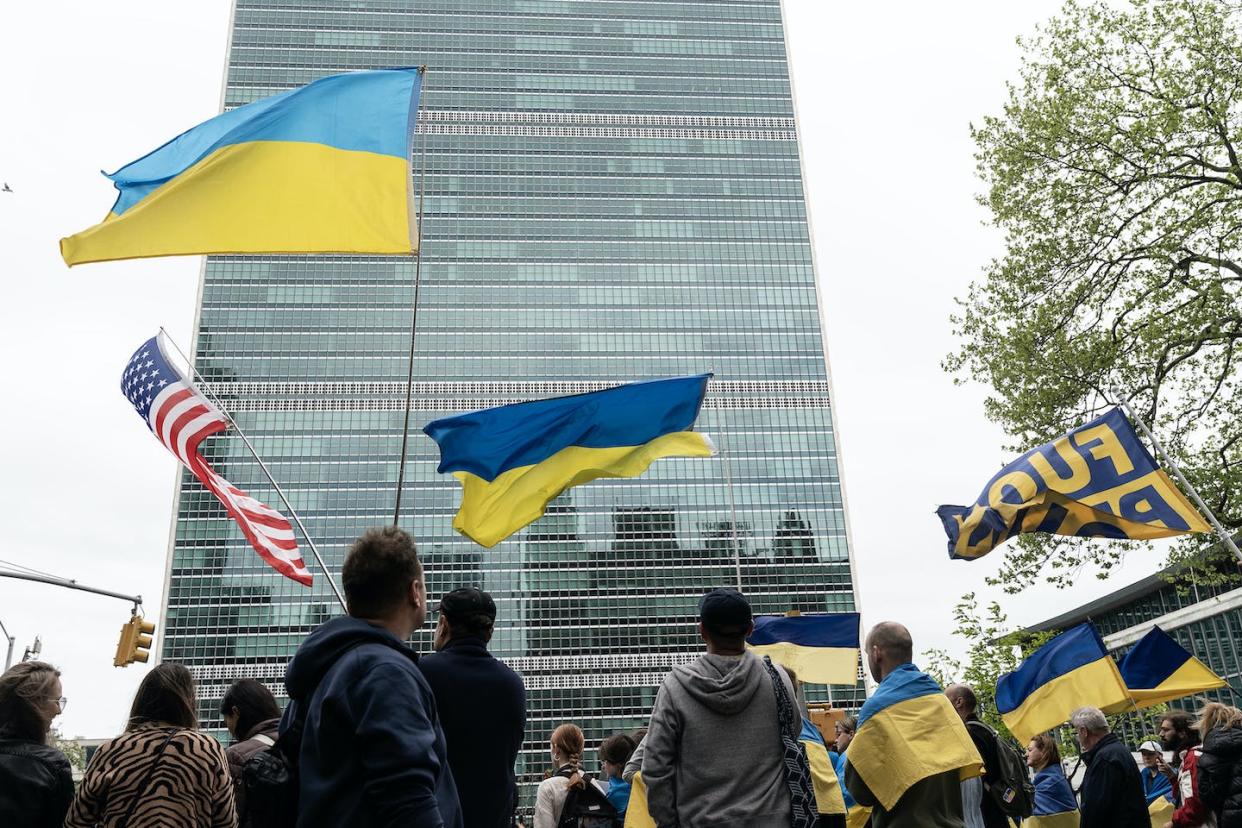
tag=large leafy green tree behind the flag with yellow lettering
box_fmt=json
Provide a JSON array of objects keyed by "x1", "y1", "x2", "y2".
[{"x1": 945, "y1": 0, "x2": 1242, "y2": 592}]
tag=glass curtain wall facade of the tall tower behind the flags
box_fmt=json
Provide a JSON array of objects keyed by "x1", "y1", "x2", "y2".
[{"x1": 161, "y1": 0, "x2": 862, "y2": 806}]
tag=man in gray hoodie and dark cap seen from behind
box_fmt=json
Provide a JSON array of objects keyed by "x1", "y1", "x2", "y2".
[{"x1": 642, "y1": 588, "x2": 801, "y2": 828}]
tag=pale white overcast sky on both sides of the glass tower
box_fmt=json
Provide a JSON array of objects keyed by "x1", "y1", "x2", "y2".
[{"x1": 0, "y1": 0, "x2": 1160, "y2": 736}]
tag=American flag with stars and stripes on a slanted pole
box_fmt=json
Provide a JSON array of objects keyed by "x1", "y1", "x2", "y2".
[{"x1": 120, "y1": 334, "x2": 312, "y2": 586}]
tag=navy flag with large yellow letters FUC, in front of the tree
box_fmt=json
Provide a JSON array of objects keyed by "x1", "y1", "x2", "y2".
[{"x1": 936, "y1": 408, "x2": 1211, "y2": 560}]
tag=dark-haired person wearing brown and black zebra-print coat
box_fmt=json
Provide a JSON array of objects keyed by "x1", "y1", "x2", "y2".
[{"x1": 65, "y1": 662, "x2": 237, "y2": 828}]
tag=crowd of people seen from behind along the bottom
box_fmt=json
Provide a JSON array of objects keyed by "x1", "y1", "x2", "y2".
[{"x1": 0, "y1": 528, "x2": 1242, "y2": 828}]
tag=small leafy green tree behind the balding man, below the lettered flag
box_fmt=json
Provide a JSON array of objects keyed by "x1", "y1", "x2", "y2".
[{"x1": 925, "y1": 592, "x2": 1054, "y2": 741}]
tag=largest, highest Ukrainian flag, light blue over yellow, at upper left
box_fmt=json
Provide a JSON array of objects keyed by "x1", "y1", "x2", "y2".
[{"x1": 61, "y1": 68, "x2": 422, "y2": 266}]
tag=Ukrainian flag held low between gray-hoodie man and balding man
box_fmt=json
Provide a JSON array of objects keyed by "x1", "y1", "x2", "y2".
[{"x1": 746, "y1": 612, "x2": 858, "y2": 684}]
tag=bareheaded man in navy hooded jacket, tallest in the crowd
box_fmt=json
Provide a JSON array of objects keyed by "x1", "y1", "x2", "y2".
[{"x1": 281, "y1": 526, "x2": 463, "y2": 828}]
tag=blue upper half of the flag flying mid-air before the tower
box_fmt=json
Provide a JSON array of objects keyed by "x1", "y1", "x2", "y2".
[{"x1": 422, "y1": 374, "x2": 712, "y2": 480}]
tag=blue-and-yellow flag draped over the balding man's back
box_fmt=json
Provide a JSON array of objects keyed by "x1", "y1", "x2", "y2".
[{"x1": 846, "y1": 663, "x2": 984, "y2": 811}]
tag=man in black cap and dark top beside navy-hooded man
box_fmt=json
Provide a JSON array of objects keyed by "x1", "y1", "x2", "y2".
[{"x1": 419, "y1": 587, "x2": 527, "y2": 828}]
